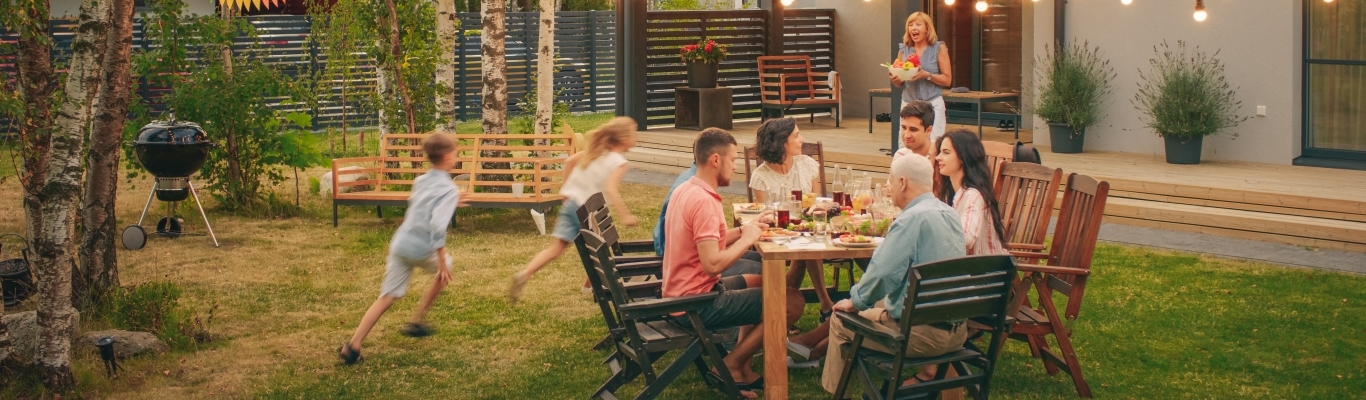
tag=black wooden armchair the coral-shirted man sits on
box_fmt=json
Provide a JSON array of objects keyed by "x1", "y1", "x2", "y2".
[{"x1": 579, "y1": 208, "x2": 740, "y2": 399}]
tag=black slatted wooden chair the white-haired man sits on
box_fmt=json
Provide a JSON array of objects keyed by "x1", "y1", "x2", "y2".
[{"x1": 835, "y1": 255, "x2": 1015, "y2": 400}]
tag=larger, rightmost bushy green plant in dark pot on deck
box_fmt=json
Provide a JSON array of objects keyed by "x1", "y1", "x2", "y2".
[{"x1": 1134, "y1": 41, "x2": 1247, "y2": 164}]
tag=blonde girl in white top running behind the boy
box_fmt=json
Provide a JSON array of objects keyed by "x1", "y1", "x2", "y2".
[{"x1": 508, "y1": 116, "x2": 639, "y2": 304}]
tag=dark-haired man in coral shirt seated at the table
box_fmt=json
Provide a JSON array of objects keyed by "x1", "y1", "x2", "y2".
[{"x1": 664, "y1": 128, "x2": 806, "y2": 397}]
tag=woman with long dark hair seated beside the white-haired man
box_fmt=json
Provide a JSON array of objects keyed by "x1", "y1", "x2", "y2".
[{"x1": 934, "y1": 130, "x2": 1009, "y2": 255}]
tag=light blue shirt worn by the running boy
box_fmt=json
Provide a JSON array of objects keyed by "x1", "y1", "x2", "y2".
[{"x1": 389, "y1": 169, "x2": 460, "y2": 259}]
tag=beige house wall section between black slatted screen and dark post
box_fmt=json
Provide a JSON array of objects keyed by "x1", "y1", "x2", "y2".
[{"x1": 787, "y1": 0, "x2": 891, "y2": 117}]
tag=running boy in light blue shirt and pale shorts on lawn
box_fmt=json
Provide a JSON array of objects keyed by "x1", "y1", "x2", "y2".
[{"x1": 337, "y1": 134, "x2": 460, "y2": 365}]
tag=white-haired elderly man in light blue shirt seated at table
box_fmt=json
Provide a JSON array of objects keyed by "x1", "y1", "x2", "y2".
[{"x1": 821, "y1": 150, "x2": 967, "y2": 393}]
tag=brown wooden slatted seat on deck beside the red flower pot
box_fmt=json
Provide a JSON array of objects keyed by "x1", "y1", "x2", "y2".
[{"x1": 758, "y1": 56, "x2": 840, "y2": 127}]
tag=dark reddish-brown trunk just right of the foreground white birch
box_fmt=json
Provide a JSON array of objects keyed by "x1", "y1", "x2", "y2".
[{"x1": 81, "y1": 0, "x2": 133, "y2": 303}]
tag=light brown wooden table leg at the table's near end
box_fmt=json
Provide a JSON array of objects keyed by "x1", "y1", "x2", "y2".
[{"x1": 764, "y1": 259, "x2": 787, "y2": 399}]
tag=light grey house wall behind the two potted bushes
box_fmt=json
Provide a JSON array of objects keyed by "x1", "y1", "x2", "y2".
[{"x1": 1033, "y1": 0, "x2": 1303, "y2": 165}]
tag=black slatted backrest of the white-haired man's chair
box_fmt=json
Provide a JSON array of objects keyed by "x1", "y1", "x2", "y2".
[{"x1": 900, "y1": 255, "x2": 1015, "y2": 333}]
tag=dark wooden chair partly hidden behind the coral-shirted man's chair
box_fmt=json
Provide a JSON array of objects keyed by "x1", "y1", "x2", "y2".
[{"x1": 574, "y1": 192, "x2": 664, "y2": 351}]
